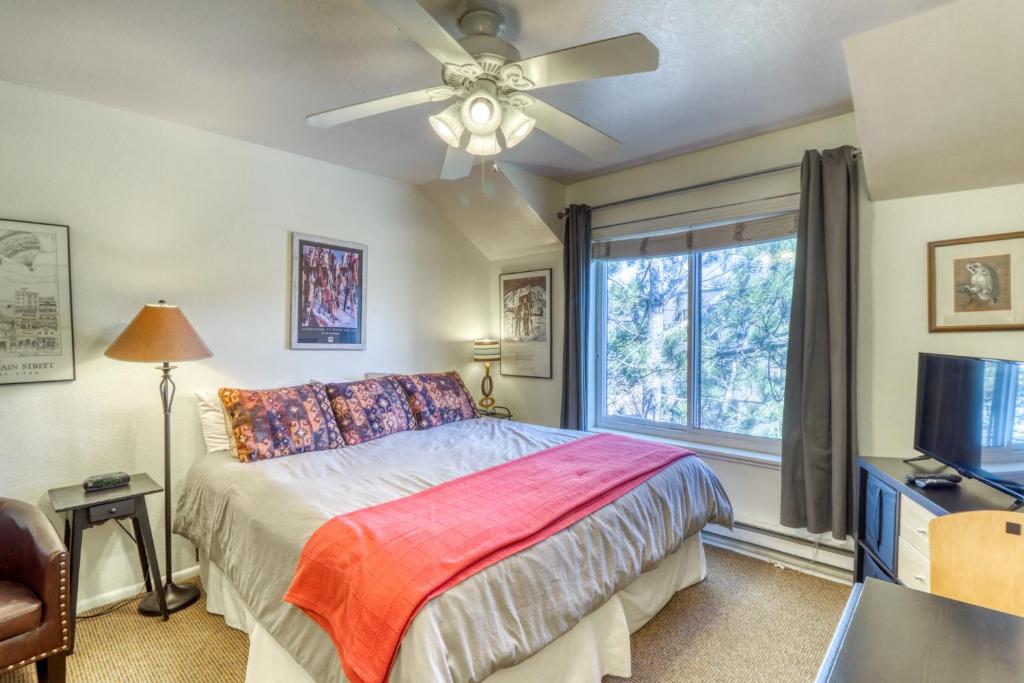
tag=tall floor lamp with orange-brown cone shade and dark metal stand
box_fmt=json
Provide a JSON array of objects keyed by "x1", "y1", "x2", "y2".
[{"x1": 104, "y1": 299, "x2": 213, "y2": 616}]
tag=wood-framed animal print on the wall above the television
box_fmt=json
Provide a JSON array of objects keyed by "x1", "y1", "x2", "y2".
[{"x1": 928, "y1": 231, "x2": 1024, "y2": 332}]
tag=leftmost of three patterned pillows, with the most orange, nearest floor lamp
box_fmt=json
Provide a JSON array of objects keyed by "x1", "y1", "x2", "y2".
[{"x1": 217, "y1": 382, "x2": 342, "y2": 463}]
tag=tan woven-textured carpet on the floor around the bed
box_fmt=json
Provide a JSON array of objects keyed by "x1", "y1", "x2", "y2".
[{"x1": 0, "y1": 547, "x2": 850, "y2": 683}]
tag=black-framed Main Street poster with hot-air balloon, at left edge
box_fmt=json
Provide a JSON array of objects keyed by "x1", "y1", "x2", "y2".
[{"x1": 0, "y1": 219, "x2": 75, "y2": 384}]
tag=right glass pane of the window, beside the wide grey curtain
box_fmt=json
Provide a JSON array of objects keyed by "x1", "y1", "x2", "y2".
[{"x1": 698, "y1": 239, "x2": 797, "y2": 438}]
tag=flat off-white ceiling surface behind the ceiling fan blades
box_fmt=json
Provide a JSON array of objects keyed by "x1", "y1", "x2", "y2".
[{"x1": 0, "y1": 0, "x2": 958, "y2": 183}]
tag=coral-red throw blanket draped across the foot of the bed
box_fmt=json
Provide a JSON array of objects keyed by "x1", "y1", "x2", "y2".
[{"x1": 285, "y1": 434, "x2": 692, "y2": 683}]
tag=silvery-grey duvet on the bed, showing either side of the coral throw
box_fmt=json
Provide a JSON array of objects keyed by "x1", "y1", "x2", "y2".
[{"x1": 174, "y1": 418, "x2": 732, "y2": 683}]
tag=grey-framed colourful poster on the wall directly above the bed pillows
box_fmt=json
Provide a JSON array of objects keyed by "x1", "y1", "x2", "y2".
[{"x1": 292, "y1": 232, "x2": 367, "y2": 350}]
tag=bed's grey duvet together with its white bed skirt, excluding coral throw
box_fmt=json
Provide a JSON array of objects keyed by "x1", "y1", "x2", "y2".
[{"x1": 174, "y1": 418, "x2": 732, "y2": 683}]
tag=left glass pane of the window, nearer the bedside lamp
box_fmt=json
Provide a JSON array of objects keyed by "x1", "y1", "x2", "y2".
[{"x1": 604, "y1": 256, "x2": 689, "y2": 425}]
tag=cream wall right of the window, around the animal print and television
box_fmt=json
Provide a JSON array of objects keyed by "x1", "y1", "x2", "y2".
[{"x1": 857, "y1": 185, "x2": 1024, "y2": 458}]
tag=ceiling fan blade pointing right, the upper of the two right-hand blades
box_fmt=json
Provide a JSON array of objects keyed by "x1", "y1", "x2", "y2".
[{"x1": 501, "y1": 33, "x2": 658, "y2": 90}]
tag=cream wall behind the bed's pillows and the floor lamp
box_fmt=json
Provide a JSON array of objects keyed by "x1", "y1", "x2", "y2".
[{"x1": 0, "y1": 83, "x2": 493, "y2": 610}]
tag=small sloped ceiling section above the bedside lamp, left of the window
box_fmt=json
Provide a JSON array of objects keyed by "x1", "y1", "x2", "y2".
[{"x1": 420, "y1": 162, "x2": 565, "y2": 261}]
